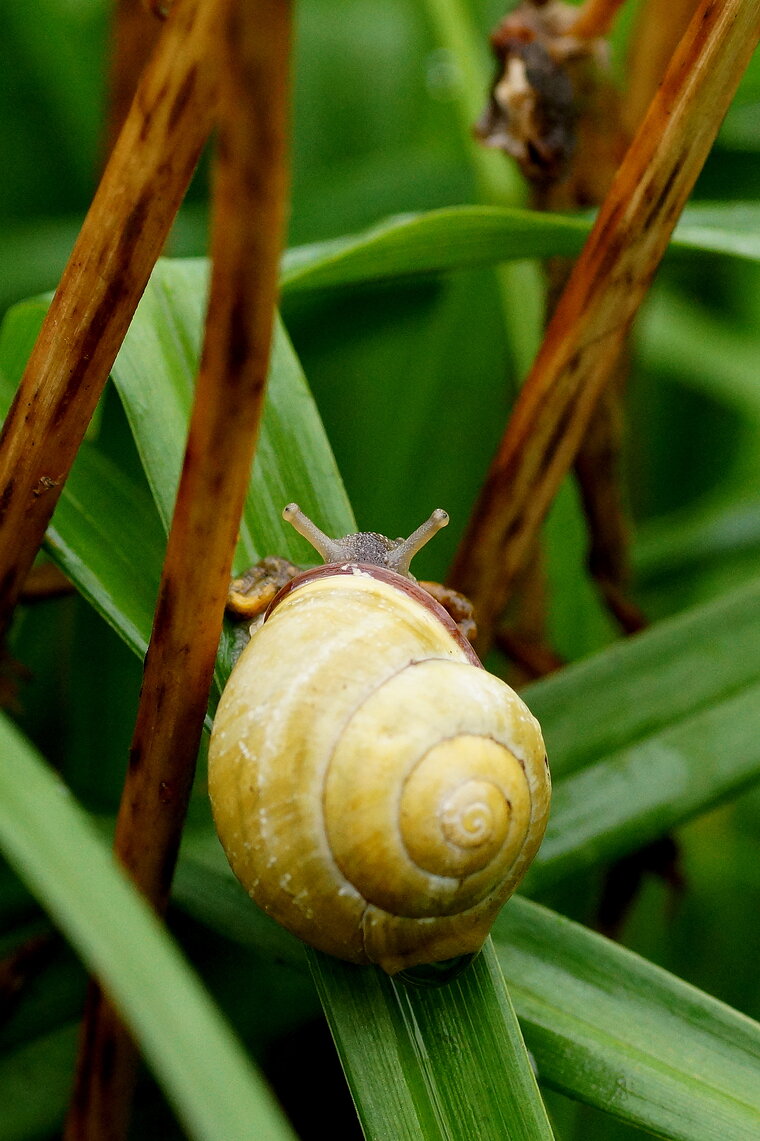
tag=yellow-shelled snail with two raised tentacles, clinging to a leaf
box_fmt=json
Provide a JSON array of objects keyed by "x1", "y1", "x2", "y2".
[{"x1": 209, "y1": 503, "x2": 550, "y2": 973}]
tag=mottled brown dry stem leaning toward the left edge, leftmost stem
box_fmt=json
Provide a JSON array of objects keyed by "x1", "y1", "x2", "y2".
[{"x1": 0, "y1": 0, "x2": 213, "y2": 632}]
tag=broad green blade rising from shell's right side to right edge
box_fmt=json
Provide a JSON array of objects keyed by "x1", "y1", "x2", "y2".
[{"x1": 525, "y1": 581, "x2": 760, "y2": 892}]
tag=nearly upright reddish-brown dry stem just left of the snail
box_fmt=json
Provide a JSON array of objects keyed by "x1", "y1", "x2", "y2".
[{"x1": 66, "y1": 0, "x2": 290, "y2": 1141}]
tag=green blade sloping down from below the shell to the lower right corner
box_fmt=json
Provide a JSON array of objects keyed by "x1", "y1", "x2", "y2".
[{"x1": 494, "y1": 898, "x2": 760, "y2": 1141}]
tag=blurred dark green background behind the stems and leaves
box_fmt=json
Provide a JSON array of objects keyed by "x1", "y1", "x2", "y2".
[{"x1": 0, "y1": 0, "x2": 760, "y2": 1138}]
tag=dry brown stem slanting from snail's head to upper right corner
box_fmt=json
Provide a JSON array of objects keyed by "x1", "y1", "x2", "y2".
[{"x1": 451, "y1": 0, "x2": 760, "y2": 653}]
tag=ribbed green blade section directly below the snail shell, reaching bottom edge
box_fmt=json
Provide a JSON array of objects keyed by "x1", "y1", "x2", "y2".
[{"x1": 309, "y1": 941, "x2": 552, "y2": 1141}]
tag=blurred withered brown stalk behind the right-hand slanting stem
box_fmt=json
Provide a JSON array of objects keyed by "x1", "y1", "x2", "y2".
[{"x1": 480, "y1": 0, "x2": 642, "y2": 652}]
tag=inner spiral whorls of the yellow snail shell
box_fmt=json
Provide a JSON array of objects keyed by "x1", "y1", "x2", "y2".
[{"x1": 324, "y1": 658, "x2": 533, "y2": 917}]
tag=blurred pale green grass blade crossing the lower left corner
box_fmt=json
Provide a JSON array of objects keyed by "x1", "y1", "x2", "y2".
[{"x1": 0, "y1": 719, "x2": 292, "y2": 1141}]
